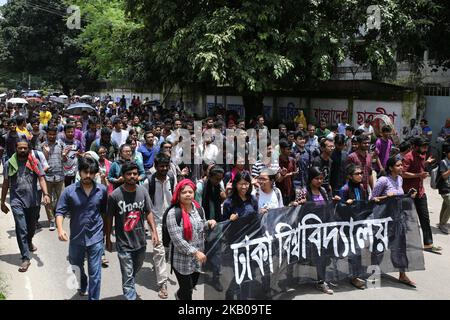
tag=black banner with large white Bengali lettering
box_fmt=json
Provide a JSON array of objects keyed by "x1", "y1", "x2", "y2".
[{"x1": 203, "y1": 197, "x2": 424, "y2": 300}]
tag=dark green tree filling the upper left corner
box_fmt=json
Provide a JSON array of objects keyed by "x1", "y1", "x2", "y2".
[{"x1": 0, "y1": 0, "x2": 84, "y2": 92}]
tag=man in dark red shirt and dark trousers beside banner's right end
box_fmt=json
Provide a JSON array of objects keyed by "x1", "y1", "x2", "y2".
[{"x1": 402, "y1": 136, "x2": 442, "y2": 254}]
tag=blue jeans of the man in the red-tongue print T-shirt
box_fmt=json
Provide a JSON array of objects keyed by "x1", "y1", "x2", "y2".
[{"x1": 117, "y1": 247, "x2": 146, "y2": 300}]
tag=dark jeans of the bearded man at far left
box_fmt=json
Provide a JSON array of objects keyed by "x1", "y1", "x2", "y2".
[{"x1": 11, "y1": 206, "x2": 40, "y2": 260}]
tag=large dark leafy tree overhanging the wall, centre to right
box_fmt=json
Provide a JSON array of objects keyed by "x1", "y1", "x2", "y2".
[{"x1": 122, "y1": 0, "x2": 450, "y2": 120}]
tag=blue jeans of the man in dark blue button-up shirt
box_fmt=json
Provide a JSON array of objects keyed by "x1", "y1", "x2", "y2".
[{"x1": 69, "y1": 241, "x2": 103, "y2": 300}]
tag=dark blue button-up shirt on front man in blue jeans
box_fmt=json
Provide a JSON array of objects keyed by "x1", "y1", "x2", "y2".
[{"x1": 55, "y1": 182, "x2": 107, "y2": 247}]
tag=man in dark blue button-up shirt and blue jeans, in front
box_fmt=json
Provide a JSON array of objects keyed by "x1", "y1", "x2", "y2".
[{"x1": 55, "y1": 157, "x2": 107, "y2": 300}]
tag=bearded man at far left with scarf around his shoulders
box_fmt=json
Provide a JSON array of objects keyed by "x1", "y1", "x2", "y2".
[{"x1": 1, "y1": 139, "x2": 50, "y2": 272}]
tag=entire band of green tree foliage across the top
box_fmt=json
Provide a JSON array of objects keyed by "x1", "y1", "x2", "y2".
[{"x1": 0, "y1": 0, "x2": 450, "y2": 94}]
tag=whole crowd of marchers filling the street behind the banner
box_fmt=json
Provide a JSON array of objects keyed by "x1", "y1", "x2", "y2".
[{"x1": 0, "y1": 95, "x2": 450, "y2": 300}]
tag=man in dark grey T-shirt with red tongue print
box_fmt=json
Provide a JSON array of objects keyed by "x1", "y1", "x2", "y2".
[{"x1": 106, "y1": 162, "x2": 159, "y2": 300}]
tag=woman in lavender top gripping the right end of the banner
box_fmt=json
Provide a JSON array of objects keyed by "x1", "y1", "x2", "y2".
[{"x1": 371, "y1": 155, "x2": 417, "y2": 288}]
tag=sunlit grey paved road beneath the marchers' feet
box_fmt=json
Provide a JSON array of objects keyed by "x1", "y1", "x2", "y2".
[{"x1": 0, "y1": 181, "x2": 450, "y2": 300}]
